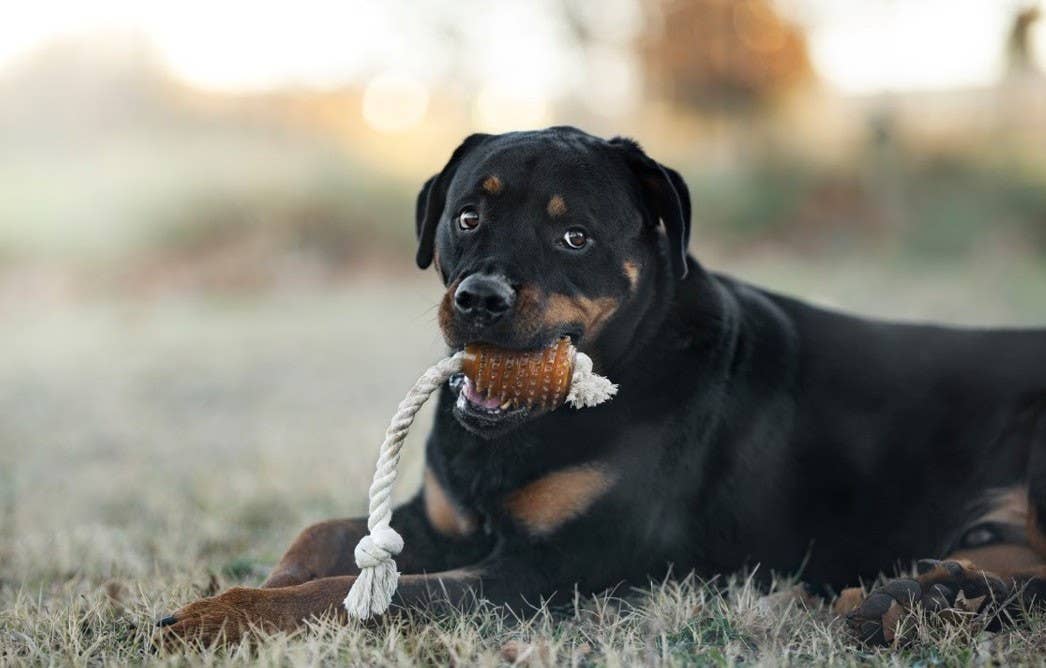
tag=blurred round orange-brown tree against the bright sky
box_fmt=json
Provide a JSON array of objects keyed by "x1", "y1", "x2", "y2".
[{"x1": 641, "y1": 0, "x2": 813, "y2": 111}]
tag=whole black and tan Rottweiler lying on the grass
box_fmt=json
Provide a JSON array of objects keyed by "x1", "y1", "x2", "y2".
[{"x1": 161, "y1": 128, "x2": 1046, "y2": 641}]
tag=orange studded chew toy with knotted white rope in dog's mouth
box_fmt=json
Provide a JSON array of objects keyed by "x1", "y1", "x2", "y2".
[{"x1": 343, "y1": 337, "x2": 617, "y2": 620}]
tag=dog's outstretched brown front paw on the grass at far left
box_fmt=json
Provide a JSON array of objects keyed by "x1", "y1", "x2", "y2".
[{"x1": 155, "y1": 588, "x2": 289, "y2": 648}]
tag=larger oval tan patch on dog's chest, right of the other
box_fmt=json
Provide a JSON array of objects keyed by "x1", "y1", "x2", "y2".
[{"x1": 505, "y1": 464, "x2": 616, "y2": 535}]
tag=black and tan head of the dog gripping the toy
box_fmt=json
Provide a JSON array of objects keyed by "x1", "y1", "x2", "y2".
[{"x1": 416, "y1": 128, "x2": 690, "y2": 437}]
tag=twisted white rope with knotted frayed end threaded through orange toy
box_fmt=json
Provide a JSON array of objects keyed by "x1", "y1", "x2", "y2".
[{"x1": 343, "y1": 352, "x2": 617, "y2": 619}]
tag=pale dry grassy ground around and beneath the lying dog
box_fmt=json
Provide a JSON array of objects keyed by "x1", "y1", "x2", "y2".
[{"x1": 0, "y1": 257, "x2": 1046, "y2": 666}]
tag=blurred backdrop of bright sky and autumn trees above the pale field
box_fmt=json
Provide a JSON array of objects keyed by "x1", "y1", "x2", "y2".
[{"x1": 0, "y1": 0, "x2": 1046, "y2": 305}]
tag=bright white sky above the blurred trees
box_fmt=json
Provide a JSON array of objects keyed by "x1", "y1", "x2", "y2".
[{"x1": 0, "y1": 0, "x2": 1046, "y2": 130}]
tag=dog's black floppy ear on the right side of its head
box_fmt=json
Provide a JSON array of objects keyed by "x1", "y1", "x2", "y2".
[{"x1": 610, "y1": 137, "x2": 690, "y2": 278}]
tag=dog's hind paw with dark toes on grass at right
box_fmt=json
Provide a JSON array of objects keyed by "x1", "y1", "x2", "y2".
[{"x1": 836, "y1": 559, "x2": 1013, "y2": 645}]
